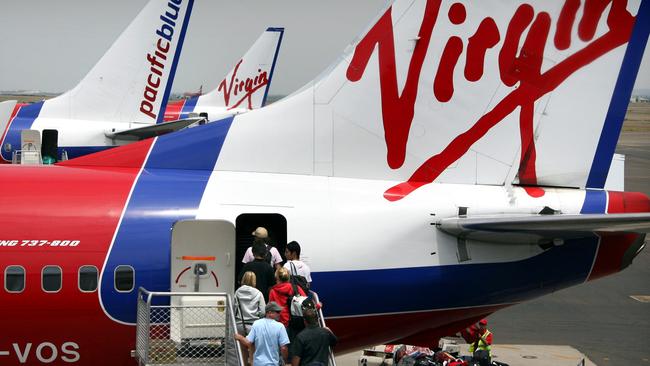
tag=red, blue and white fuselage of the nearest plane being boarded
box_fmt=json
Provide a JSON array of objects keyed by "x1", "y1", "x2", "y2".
[{"x1": 0, "y1": 150, "x2": 650, "y2": 365}]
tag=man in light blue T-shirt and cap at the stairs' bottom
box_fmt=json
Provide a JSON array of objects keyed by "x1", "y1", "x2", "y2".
[{"x1": 235, "y1": 301, "x2": 289, "y2": 366}]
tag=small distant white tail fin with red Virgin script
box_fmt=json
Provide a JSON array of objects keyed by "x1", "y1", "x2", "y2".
[{"x1": 194, "y1": 28, "x2": 284, "y2": 112}]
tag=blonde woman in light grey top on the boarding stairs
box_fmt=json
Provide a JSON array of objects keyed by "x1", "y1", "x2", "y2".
[{"x1": 235, "y1": 271, "x2": 266, "y2": 335}]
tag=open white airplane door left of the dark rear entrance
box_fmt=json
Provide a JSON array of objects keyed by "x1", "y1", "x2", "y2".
[{"x1": 170, "y1": 220, "x2": 235, "y2": 293}]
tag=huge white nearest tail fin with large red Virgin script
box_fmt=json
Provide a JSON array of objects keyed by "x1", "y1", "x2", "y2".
[{"x1": 218, "y1": 0, "x2": 650, "y2": 200}]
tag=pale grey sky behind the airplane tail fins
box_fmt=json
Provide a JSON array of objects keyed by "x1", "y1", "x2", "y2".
[{"x1": 0, "y1": 0, "x2": 650, "y2": 95}]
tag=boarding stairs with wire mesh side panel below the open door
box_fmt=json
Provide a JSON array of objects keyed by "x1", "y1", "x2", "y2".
[{"x1": 132, "y1": 287, "x2": 336, "y2": 366}]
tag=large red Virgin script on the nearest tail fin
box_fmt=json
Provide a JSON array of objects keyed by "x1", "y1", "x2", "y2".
[{"x1": 346, "y1": 0, "x2": 635, "y2": 201}]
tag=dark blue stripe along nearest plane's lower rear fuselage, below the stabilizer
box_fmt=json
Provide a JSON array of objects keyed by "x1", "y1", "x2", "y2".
[{"x1": 312, "y1": 239, "x2": 597, "y2": 317}]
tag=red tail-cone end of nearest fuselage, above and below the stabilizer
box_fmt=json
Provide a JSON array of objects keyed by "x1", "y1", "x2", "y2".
[{"x1": 589, "y1": 191, "x2": 650, "y2": 281}]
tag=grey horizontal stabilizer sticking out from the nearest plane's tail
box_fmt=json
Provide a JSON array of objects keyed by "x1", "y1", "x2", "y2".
[{"x1": 435, "y1": 213, "x2": 650, "y2": 244}]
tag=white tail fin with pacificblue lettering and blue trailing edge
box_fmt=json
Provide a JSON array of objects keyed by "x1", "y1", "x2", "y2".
[{"x1": 40, "y1": 0, "x2": 194, "y2": 123}]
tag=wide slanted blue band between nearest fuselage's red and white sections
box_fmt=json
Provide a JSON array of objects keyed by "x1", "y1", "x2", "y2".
[{"x1": 101, "y1": 118, "x2": 232, "y2": 323}]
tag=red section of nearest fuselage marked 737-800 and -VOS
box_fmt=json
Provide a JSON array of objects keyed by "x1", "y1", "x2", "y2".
[{"x1": 0, "y1": 140, "x2": 151, "y2": 365}]
